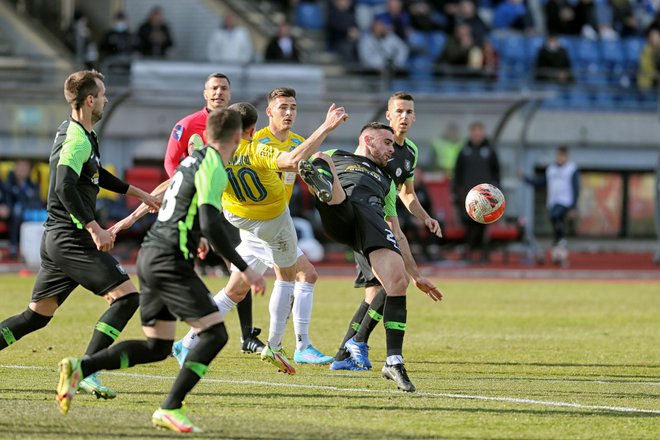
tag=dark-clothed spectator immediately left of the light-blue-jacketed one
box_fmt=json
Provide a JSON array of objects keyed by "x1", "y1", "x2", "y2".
[{"x1": 325, "y1": 0, "x2": 360, "y2": 62}]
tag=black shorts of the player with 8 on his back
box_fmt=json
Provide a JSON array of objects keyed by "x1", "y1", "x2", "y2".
[{"x1": 137, "y1": 246, "x2": 218, "y2": 326}]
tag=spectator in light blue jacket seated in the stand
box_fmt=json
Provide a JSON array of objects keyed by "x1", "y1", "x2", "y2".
[{"x1": 358, "y1": 19, "x2": 409, "y2": 74}]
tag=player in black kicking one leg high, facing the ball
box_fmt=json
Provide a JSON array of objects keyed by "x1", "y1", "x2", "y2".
[{"x1": 298, "y1": 122, "x2": 442, "y2": 392}]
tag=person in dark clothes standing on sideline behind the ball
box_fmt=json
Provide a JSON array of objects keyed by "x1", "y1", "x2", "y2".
[{"x1": 452, "y1": 121, "x2": 500, "y2": 262}]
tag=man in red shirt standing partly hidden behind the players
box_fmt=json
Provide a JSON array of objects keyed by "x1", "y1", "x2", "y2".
[{"x1": 164, "y1": 73, "x2": 265, "y2": 355}]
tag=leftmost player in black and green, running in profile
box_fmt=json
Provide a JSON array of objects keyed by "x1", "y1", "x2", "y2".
[{"x1": 0, "y1": 70, "x2": 160, "y2": 399}]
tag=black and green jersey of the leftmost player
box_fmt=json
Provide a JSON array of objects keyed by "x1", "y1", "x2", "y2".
[{"x1": 45, "y1": 119, "x2": 101, "y2": 230}]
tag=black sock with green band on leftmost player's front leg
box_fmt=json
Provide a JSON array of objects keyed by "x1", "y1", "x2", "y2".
[{"x1": 85, "y1": 292, "x2": 140, "y2": 355}]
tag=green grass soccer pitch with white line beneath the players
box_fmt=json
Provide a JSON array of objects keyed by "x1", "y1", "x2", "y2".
[{"x1": 0, "y1": 275, "x2": 660, "y2": 439}]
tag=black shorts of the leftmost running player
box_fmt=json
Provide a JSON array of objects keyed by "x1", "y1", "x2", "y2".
[{"x1": 32, "y1": 229, "x2": 129, "y2": 304}]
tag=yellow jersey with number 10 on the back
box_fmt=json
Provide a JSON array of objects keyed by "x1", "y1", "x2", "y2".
[{"x1": 222, "y1": 138, "x2": 289, "y2": 220}]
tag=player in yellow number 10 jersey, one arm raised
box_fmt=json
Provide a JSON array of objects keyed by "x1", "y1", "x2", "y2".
[{"x1": 175, "y1": 97, "x2": 347, "y2": 374}]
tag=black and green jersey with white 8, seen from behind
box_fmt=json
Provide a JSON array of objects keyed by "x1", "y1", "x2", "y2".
[{"x1": 142, "y1": 147, "x2": 227, "y2": 260}]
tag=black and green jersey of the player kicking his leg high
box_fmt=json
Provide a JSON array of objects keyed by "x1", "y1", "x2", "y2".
[{"x1": 326, "y1": 150, "x2": 396, "y2": 218}]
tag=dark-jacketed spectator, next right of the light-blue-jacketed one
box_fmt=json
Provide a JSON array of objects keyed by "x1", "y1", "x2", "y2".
[{"x1": 437, "y1": 23, "x2": 483, "y2": 77}]
